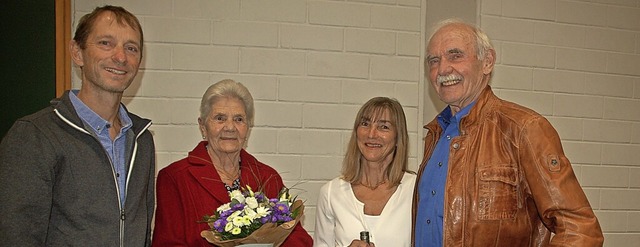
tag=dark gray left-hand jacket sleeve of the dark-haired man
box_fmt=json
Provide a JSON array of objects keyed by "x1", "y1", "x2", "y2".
[{"x1": 0, "y1": 120, "x2": 56, "y2": 246}]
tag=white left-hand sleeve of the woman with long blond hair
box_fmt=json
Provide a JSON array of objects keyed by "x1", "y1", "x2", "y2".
[{"x1": 313, "y1": 182, "x2": 335, "y2": 247}]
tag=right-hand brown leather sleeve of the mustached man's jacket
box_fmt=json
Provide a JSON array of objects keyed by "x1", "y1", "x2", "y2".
[{"x1": 519, "y1": 117, "x2": 604, "y2": 246}]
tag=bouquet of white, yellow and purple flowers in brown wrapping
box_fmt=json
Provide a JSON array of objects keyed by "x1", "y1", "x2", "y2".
[{"x1": 200, "y1": 185, "x2": 304, "y2": 247}]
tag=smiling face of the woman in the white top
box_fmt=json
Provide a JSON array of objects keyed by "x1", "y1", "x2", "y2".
[{"x1": 356, "y1": 109, "x2": 398, "y2": 165}]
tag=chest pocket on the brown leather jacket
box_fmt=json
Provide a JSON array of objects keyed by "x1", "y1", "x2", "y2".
[{"x1": 476, "y1": 165, "x2": 518, "y2": 220}]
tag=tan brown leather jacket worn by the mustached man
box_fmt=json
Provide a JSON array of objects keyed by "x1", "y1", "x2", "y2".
[{"x1": 413, "y1": 86, "x2": 604, "y2": 247}]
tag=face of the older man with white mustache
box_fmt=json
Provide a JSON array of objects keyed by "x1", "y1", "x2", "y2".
[{"x1": 426, "y1": 24, "x2": 495, "y2": 114}]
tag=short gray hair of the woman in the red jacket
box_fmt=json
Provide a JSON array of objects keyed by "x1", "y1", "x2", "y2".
[{"x1": 200, "y1": 79, "x2": 254, "y2": 127}]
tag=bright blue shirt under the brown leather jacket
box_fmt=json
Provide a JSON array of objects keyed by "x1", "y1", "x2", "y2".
[{"x1": 415, "y1": 102, "x2": 475, "y2": 247}]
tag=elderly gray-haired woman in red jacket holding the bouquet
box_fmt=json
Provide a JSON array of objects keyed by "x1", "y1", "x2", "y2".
[{"x1": 152, "y1": 80, "x2": 312, "y2": 247}]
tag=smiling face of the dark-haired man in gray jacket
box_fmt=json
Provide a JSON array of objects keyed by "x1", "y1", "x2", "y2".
[{"x1": 71, "y1": 12, "x2": 142, "y2": 93}]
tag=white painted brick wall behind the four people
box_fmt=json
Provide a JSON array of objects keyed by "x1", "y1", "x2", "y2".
[{"x1": 67, "y1": 0, "x2": 640, "y2": 246}]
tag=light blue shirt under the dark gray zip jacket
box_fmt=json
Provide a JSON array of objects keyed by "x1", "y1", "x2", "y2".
[{"x1": 69, "y1": 90, "x2": 133, "y2": 207}]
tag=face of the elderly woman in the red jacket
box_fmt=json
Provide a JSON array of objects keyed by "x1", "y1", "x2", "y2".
[{"x1": 198, "y1": 97, "x2": 249, "y2": 153}]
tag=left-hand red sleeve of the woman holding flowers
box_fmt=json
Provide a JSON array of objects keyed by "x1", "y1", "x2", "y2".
[{"x1": 151, "y1": 170, "x2": 188, "y2": 247}]
